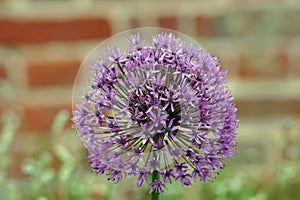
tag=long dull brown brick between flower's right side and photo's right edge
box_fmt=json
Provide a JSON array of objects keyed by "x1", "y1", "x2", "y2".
[{"x1": 236, "y1": 100, "x2": 300, "y2": 116}]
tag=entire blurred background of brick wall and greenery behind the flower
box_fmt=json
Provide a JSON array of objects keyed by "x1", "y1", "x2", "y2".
[{"x1": 0, "y1": 0, "x2": 300, "y2": 200}]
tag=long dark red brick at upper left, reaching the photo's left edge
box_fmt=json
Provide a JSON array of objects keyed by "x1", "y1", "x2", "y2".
[{"x1": 0, "y1": 19, "x2": 111, "y2": 43}]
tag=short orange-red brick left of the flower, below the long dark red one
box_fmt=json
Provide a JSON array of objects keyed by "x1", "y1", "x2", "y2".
[{"x1": 27, "y1": 61, "x2": 80, "y2": 86}]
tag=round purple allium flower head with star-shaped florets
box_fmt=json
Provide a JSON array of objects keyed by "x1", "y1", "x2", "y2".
[{"x1": 73, "y1": 28, "x2": 237, "y2": 193}]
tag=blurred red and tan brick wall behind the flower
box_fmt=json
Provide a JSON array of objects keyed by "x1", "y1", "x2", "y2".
[{"x1": 0, "y1": 0, "x2": 300, "y2": 175}]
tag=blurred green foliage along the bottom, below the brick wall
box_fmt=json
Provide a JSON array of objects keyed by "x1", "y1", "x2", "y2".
[{"x1": 0, "y1": 110, "x2": 300, "y2": 200}]
